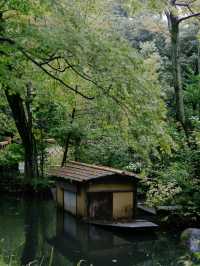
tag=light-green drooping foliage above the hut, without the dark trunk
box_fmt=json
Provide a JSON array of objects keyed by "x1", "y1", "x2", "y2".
[{"x1": 2, "y1": 1, "x2": 172, "y2": 170}]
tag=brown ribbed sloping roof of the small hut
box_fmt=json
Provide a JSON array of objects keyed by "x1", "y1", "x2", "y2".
[{"x1": 48, "y1": 161, "x2": 138, "y2": 182}]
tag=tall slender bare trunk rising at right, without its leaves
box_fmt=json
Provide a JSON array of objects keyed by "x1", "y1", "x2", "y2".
[{"x1": 167, "y1": 13, "x2": 186, "y2": 129}]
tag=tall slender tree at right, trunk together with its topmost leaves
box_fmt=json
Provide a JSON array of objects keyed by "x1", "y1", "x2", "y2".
[{"x1": 124, "y1": 0, "x2": 200, "y2": 134}]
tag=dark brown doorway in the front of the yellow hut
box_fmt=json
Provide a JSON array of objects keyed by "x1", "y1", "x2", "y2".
[{"x1": 88, "y1": 192, "x2": 113, "y2": 220}]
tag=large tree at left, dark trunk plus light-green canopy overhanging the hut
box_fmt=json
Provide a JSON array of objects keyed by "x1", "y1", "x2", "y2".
[{"x1": 0, "y1": 0, "x2": 173, "y2": 179}]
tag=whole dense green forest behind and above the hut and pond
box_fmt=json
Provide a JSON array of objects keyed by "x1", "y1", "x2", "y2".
[{"x1": 0, "y1": 0, "x2": 200, "y2": 220}]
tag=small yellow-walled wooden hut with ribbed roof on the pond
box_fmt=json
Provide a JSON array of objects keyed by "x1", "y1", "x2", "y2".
[{"x1": 49, "y1": 161, "x2": 138, "y2": 221}]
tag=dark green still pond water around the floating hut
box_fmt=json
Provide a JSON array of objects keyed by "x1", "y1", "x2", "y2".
[{"x1": 0, "y1": 197, "x2": 188, "y2": 266}]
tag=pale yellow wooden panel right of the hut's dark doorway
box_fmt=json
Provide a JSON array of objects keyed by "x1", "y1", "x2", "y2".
[{"x1": 113, "y1": 192, "x2": 134, "y2": 219}]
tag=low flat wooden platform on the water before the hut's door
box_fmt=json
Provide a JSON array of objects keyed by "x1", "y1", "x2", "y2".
[{"x1": 88, "y1": 220, "x2": 159, "y2": 230}]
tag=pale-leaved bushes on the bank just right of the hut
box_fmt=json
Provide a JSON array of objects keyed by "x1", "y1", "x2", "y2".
[{"x1": 147, "y1": 156, "x2": 200, "y2": 220}]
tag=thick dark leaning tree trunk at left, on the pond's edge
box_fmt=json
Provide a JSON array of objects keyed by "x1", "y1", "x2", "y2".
[{"x1": 5, "y1": 89, "x2": 39, "y2": 182}]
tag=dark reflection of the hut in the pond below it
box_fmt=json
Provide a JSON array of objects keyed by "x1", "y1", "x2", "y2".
[{"x1": 48, "y1": 211, "x2": 156, "y2": 266}]
